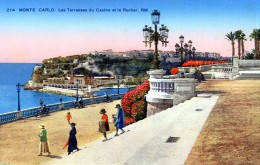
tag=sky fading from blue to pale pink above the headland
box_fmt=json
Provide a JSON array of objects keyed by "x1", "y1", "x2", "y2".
[{"x1": 0, "y1": 0, "x2": 260, "y2": 63}]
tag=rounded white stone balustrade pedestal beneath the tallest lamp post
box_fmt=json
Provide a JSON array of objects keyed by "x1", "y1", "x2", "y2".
[{"x1": 146, "y1": 70, "x2": 195, "y2": 116}]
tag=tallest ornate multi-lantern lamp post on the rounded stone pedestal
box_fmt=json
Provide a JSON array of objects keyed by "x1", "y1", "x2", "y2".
[{"x1": 143, "y1": 10, "x2": 169, "y2": 69}]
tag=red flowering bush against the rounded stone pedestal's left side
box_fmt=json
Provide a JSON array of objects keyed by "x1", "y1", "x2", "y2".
[{"x1": 121, "y1": 80, "x2": 150, "y2": 125}]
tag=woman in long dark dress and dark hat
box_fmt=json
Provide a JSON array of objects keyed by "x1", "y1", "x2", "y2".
[{"x1": 68, "y1": 123, "x2": 79, "y2": 155}]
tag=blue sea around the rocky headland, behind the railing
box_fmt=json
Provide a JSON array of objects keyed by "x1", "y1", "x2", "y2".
[{"x1": 0, "y1": 63, "x2": 132, "y2": 114}]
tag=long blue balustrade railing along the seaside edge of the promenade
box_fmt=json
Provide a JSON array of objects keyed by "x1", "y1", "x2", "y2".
[{"x1": 0, "y1": 93, "x2": 124, "y2": 124}]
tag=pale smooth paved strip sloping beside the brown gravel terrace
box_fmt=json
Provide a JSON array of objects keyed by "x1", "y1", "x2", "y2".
[{"x1": 44, "y1": 94, "x2": 218, "y2": 165}]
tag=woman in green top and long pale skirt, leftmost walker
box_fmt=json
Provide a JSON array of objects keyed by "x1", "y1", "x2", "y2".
[{"x1": 39, "y1": 124, "x2": 51, "y2": 156}]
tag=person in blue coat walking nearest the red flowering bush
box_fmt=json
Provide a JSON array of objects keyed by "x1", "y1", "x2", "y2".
[{"x1": 115, "y1": 104, "x2": 125, "y2": 136}]
